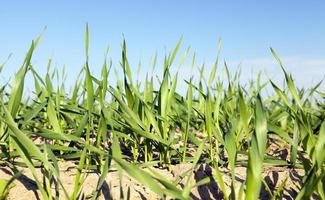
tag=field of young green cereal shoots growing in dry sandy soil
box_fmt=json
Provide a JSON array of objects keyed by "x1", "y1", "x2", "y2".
[{"x1": 0, "y1": 27, "x2": 325, "y2": 199}]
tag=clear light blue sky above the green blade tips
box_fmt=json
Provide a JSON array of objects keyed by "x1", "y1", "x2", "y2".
[{"x1": 0, "y1": 0, "x2": 325, "y2": 90}]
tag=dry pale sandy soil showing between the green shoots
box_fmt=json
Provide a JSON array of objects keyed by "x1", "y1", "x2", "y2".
[{"x1": 0, "y1": 133, "x2": 319, "y2": 200}]
